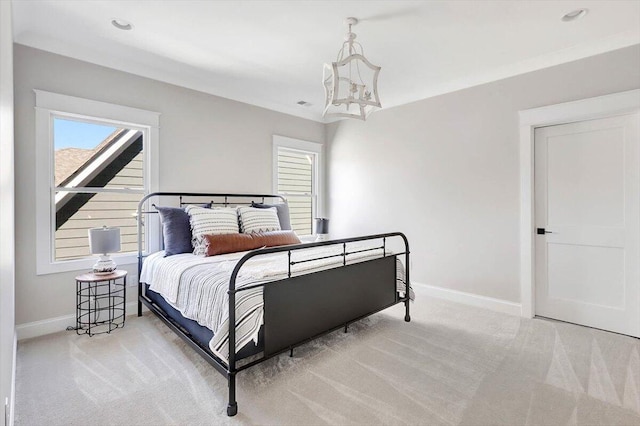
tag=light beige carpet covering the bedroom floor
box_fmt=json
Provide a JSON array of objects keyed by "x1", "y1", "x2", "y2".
[{"x1": 15, "y1": 289, "x2": 640, "y2": 426}]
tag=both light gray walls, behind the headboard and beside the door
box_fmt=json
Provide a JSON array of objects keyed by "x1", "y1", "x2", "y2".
[{"x1": 14, "y1": 41, "x2": 640, "y2": 324}]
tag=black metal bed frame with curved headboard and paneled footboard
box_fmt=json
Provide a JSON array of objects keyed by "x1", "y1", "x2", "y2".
[{"x1": 137, "y1": 192, "x2": 411, "y2": 416}]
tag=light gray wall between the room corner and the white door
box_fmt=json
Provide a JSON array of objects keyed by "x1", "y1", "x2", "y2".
[{"x1": 327, "y1": 45, "x2": 640, "y2": 302}]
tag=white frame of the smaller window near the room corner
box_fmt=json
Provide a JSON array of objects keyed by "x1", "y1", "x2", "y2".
[{"x1": 272, "y1": 135, "x2": 324, "y2": 237}]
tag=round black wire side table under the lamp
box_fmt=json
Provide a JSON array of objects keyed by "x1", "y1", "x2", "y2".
[{"x1": 76, "y1": 270, "x2": 127, "y2": 336}]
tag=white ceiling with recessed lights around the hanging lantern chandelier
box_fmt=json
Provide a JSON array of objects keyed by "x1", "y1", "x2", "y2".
[{"x1": 13, "y1": 0, "x2": 640, "y2": 121}]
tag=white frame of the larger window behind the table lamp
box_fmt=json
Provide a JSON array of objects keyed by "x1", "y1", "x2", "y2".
[{"x1": 34, "y1": 90, "x2": 160, "y2": 275}]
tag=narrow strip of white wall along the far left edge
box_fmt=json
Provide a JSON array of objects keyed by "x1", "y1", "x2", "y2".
[{"x1": 0, "y1": 2, "x2": 16, "y2": 424}]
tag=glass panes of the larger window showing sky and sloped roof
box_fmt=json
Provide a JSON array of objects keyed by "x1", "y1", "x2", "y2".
[{"x1": 52, "y1": 118, "x2": 146, "y2": 261}]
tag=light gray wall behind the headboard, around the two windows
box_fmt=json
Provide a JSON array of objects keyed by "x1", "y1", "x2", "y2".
[{"x1": 14, "y1": 45, "x2": 325, "y2": 324}]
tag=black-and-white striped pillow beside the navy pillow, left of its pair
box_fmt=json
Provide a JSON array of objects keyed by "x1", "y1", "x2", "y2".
[{"x1": 185, "y1": 205, "x2": 239, "y2": 256}]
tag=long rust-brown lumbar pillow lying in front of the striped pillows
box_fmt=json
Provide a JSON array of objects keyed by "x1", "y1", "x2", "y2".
[{"x1": 204, "y1": 231, "x2": 300, "y2": 256}]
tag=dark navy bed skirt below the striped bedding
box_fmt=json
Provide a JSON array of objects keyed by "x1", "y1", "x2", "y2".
[{"x1": 144, "y1": 284, "x2": 264, "y2": 359}]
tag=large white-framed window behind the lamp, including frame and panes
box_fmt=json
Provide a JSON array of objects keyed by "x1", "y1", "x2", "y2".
[{"x1": 36, "y1": 91, "x2": 158, "y2": 274}]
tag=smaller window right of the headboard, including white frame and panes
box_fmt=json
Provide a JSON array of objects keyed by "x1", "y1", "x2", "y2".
[{"x1": 273, "y1": 136, "x2": 322, "y2": 235}]
